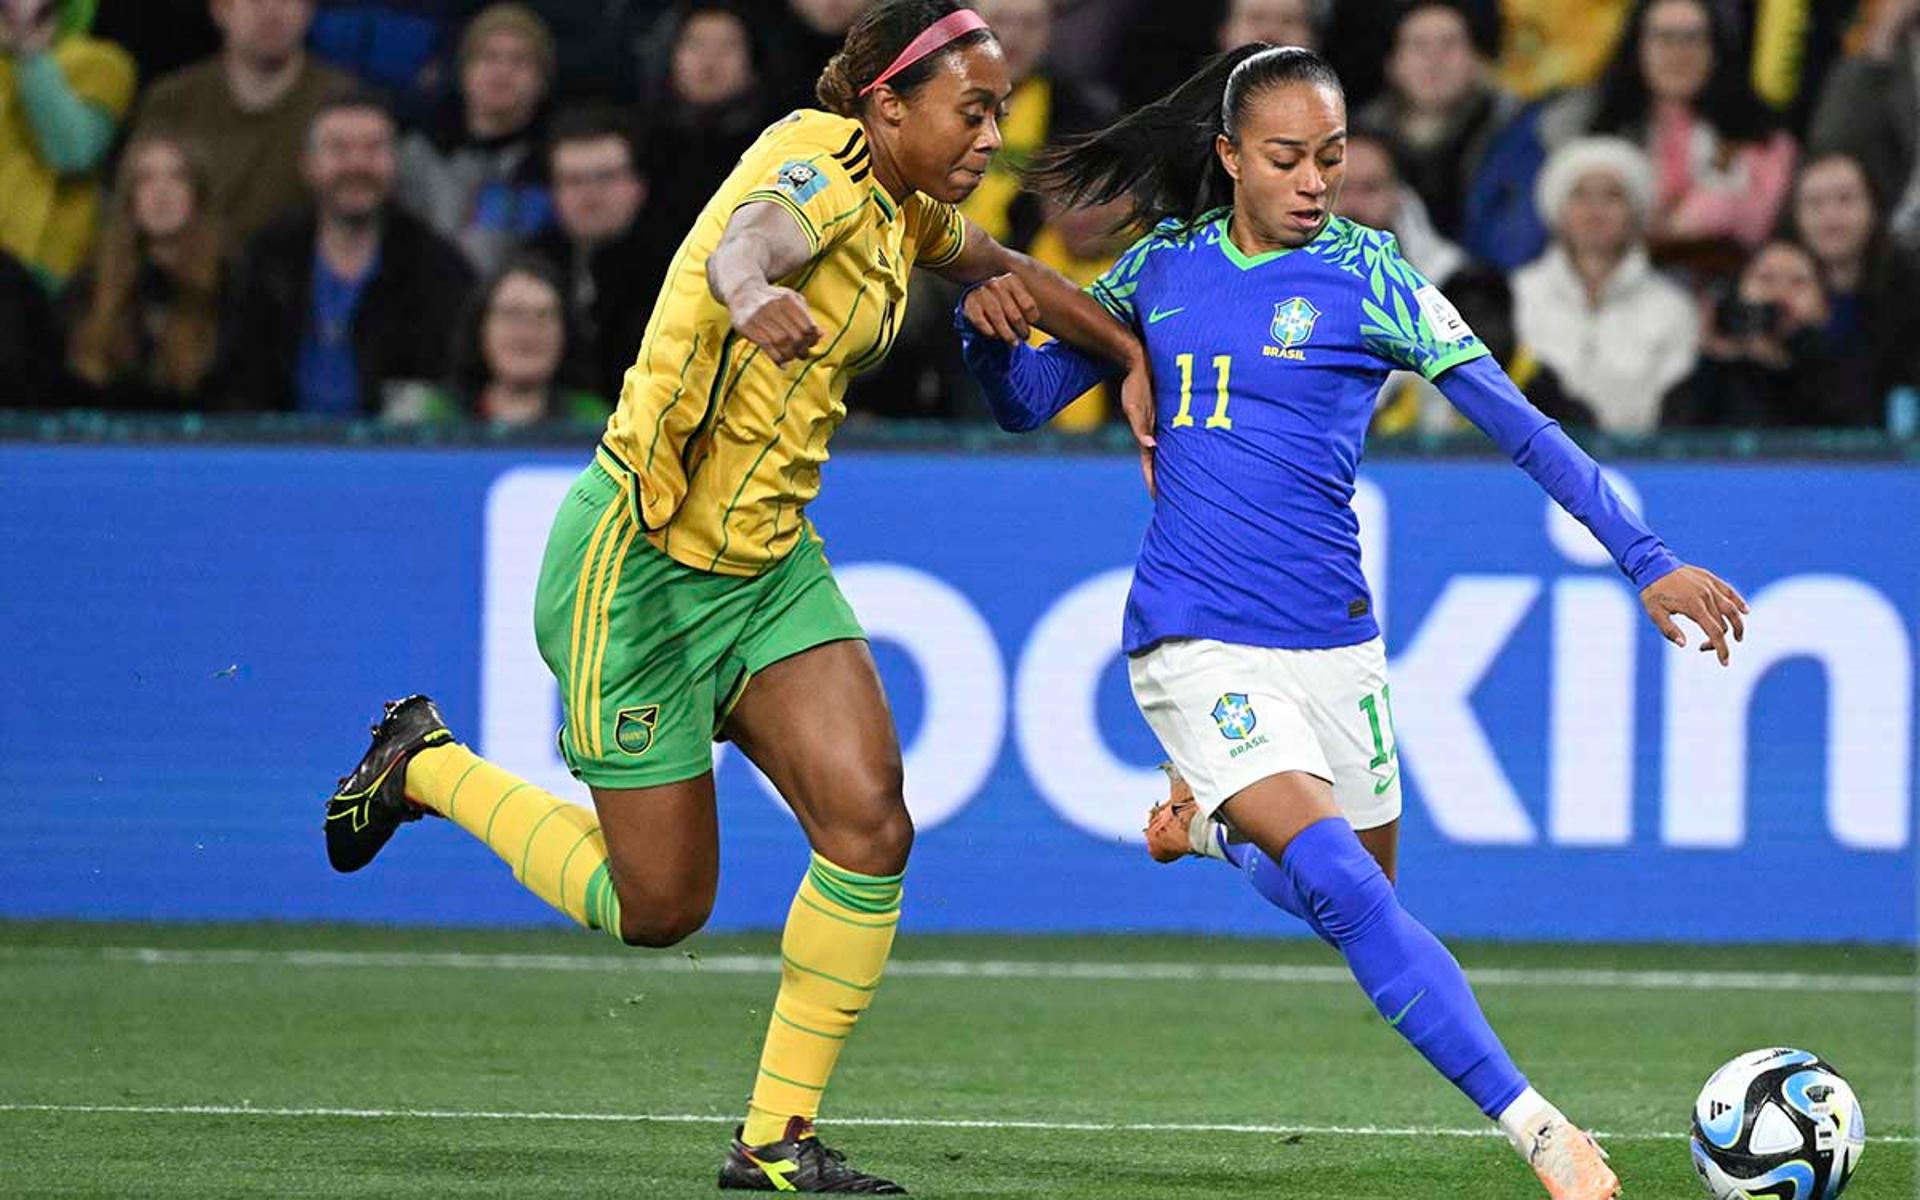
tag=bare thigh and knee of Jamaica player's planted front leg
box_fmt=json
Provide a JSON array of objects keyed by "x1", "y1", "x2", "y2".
[{"x1": 728, "y1": 641, "x2": 914, "y2": 876}]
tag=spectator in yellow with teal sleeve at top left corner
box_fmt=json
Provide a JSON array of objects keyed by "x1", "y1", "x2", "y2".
[{"x1": 0, "y1": 0, "x2": 134, "y2": 288}]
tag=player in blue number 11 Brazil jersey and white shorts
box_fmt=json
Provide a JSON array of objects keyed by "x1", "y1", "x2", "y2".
[{"x1": 956, "y1": 46, "x2": 1745, "y2": 1200}]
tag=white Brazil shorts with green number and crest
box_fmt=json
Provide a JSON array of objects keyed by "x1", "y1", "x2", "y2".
[{"x1": 1127, "y1": 637, "x2": 1400, "y2": 829}]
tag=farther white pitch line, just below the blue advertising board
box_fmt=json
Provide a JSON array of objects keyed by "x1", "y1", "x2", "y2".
[{"x1": 0, "y1": 947, "x2": 1920, "y2": 995}]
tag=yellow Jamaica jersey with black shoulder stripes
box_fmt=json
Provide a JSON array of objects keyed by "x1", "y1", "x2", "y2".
[{"x1": 599, "y1": 109, "x2": 966, "y2": 576}]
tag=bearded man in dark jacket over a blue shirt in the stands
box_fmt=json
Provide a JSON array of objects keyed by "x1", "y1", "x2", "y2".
[{"x1": 217, "y1": 94, "x2": 472, "y2": 417}]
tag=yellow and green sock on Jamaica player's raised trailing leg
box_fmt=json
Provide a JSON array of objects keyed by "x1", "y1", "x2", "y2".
[{"x1": 407, "y1": 743, "x2": 620, "y2": 937}]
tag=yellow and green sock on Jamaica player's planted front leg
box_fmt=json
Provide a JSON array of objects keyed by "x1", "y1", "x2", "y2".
[{"x1": 741, "y1": 854, "x2": 900, "y2": 1146}]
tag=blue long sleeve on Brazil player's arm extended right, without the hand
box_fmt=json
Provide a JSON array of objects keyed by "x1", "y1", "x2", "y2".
[{"x1": 1434, "y1": 357, "x2": 1680, "y2": 588}]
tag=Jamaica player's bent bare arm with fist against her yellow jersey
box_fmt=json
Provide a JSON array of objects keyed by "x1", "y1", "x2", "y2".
[{"x1": 707, "y1": 200, "x2": 820, "y2": 367}]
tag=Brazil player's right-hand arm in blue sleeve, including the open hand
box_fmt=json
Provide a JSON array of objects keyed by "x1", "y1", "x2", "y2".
[{"x1": 1434, "y1": 357, "x2": 1747, "y2": 666}]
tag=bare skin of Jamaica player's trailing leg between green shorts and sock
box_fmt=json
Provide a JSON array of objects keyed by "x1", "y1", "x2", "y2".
[{"x1": 593, "y1": 774, "x2": 720, "y2": 947}]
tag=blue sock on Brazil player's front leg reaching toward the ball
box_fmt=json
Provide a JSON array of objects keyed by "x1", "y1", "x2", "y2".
[{"x1": 1274, "y1": 818, "x2": 1526, "y2": 1117}]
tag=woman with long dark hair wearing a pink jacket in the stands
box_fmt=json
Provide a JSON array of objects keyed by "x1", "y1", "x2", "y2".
[{"x1": 1592, "y1": 0, "x2": 1795, "y2": 261}]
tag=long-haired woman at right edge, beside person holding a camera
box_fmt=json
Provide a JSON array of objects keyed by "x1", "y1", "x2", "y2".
[{"x1": 1784, "y1": 154, "x2": 1920, "y2": 420}]
